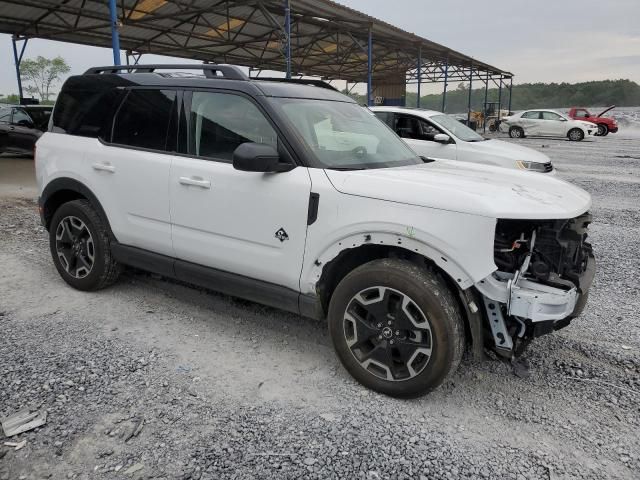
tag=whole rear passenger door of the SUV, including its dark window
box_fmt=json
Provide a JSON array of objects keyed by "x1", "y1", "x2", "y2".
[{"x1": 85, "y1": 88, "x2": 178, "y2": 256}]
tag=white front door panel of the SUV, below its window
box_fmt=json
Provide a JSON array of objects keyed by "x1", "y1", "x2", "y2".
[{"x1": 169, "y1": 156, "x2": 311, "y2": 290}]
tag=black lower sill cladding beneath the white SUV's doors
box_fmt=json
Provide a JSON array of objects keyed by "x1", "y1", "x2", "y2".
[{"x1": 111, "y1": 242, "x2": 322, "y2": 318}]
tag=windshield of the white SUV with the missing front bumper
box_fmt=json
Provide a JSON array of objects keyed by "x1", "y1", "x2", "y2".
[{"x1": 272, "y1": 98, "x2": 423, "y2": 170}]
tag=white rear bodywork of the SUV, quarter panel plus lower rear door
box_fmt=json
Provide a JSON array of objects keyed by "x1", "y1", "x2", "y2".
[{"x1": 36, "y1": 133, "x2": 174, "y2": 256}]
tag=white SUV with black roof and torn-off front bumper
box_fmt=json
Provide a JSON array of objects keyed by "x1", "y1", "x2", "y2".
[{"x1": 36, "y1": 65, "x2": 594, "y2": 397}]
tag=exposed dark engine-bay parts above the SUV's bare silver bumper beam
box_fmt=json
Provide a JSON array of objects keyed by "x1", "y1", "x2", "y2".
[{"x1": 494, "y1": 213, "x2": 595, "y2": 294}]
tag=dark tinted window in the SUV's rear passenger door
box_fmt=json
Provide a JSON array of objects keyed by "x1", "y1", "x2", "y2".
[{"x1": 112, "y1": 90, "x2": 176, "y2": 150}]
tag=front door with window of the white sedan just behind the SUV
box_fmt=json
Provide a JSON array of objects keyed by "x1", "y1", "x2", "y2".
[{"x1": 392, "y1": 113, "x2": 458, "y2": 160}]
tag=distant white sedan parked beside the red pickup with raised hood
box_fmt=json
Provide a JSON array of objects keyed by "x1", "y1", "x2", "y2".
[{"x1": 500, "y1": 109, "x2": 598, "y2": 142}]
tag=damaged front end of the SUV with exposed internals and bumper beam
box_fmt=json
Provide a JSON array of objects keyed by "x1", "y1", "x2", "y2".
[{"x1": 475, "y1": 213, "x2": 595, "y2": 358}]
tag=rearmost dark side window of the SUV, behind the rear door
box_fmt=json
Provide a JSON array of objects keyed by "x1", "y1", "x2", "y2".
[{"x1": 51, "y1": 75, "x2": 129, "y2": 140}]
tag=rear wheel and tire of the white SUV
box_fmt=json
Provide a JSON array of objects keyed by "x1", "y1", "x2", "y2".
[{"x1": 49, "y1": 200, "x2": 122, "y2": 291}]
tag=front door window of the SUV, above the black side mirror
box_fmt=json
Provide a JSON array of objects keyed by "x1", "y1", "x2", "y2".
[{"x1": 189, "y1": 92, "x2": 278, "y2": 162}]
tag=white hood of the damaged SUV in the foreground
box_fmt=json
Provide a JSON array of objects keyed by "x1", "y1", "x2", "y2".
[{"x1": 325, "y1": 160, "x2": 591, "y2": 220}]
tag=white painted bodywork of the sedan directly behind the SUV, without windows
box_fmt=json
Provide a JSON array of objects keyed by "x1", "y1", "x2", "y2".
[{"x1": 371, "y1": 107, "x2": 555, "y2": 173}]
